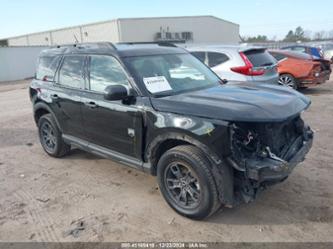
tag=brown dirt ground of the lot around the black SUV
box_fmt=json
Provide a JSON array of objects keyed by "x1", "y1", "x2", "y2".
[{"x1": 0, "y1": 78, "x2": 333, "y2": 242}]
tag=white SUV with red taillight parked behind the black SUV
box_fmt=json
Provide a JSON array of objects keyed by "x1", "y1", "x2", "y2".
[{"x1": 186, "y1": 45, "x2": 278, "y2": 84}]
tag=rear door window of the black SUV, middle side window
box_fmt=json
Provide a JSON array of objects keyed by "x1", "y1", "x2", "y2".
[{"x1": 59, "y1": 55, "x2": 86, "y2": 88}]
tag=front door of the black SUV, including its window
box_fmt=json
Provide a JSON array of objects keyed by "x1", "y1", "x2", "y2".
[{"x1": 82, "y1": 55, "x2": 142, "y2": 159}]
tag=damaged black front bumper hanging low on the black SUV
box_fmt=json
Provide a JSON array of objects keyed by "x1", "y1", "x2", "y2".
[{"x1": 246, "y1": 129, "x2": 313, "y2": 184}]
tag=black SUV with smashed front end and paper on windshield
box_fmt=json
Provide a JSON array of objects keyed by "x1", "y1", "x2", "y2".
[{"x1": 30, "y1": 43, "x2": 313, "y2": 219}]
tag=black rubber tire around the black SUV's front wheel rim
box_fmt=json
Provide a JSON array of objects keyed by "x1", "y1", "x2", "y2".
[{"x1": 157, "y1": 147, "x2": 215, "y2": 219}]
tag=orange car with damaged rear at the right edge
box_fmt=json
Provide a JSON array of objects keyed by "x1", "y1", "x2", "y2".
[{"x1": 269, "y1": 50, "x2": 331, "y2": 89}]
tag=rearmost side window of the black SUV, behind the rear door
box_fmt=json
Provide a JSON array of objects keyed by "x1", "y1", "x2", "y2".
[{"x1": 36, "y1": 56, "x2": 61, "y2": 81}]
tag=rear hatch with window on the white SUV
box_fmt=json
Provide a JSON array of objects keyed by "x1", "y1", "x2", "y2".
[{"x1": 244, "y1": 49, "x2": 279, "y2": 83}]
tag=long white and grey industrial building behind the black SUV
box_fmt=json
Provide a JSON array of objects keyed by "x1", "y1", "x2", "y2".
[{"x1": 0, "y1": 16, "x2": 240, "y2": 46}]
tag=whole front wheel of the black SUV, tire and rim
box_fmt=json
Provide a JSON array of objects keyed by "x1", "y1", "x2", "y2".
[{"x1": 157, "y1": 145, "x2": 221, "y2": 220}]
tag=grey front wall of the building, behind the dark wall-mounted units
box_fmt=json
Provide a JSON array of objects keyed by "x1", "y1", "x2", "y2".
[{"x1": 119, "y1": 16, "x2": 240, "y2": 43}]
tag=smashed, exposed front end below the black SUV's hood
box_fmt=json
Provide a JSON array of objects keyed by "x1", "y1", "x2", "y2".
[{"x1": 229, "y1": 117, "x2": 312, "y2": 181}]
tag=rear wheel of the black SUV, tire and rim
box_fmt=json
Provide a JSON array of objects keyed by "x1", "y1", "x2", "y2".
[{"x1": 37, "y1": 114, "x2": 71, "y2": 157}]
